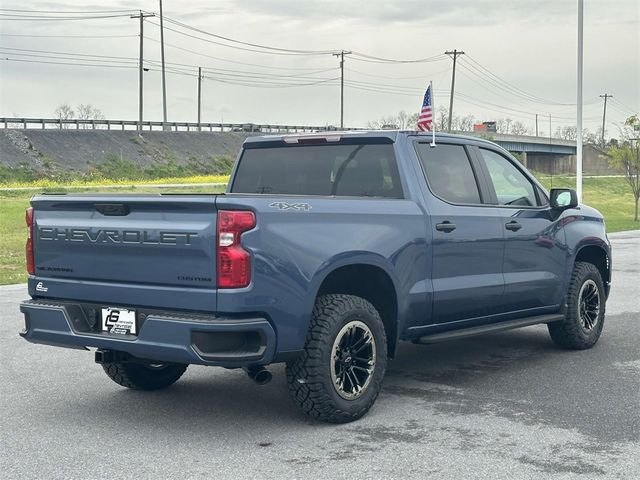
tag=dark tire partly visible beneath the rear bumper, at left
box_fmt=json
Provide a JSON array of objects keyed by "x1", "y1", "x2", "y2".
[{"x1": 102, "y1": 362, "x2": 187, "y2": 390}]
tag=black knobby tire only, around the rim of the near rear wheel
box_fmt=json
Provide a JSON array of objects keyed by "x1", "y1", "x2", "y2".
[{"x1": 286, "y1": 294, "x2": 387, "y2": 423}]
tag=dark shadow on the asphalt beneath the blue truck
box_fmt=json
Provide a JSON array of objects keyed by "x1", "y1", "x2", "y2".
[{"x1": 57, "y1": 328, "x2": 580, "y2": 430}]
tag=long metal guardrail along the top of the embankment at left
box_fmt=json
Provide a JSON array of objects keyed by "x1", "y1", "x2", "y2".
[{"x1": 0, "y1": 117, "x2": 359, "y2": 133}]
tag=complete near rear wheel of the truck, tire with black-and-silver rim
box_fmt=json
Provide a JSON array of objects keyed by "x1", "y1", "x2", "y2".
[{"x1": 287, "y1": 294, "x2": 387, "y2": 423}]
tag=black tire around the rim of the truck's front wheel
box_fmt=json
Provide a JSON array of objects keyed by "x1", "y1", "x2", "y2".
[{"x1": 547, "y1": 262, "x2": 605, "y2": 350}]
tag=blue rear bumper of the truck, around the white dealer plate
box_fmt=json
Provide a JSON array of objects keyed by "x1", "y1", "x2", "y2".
[{"x1": 20, "y1": 300, "x2": 276, "y2": 368}]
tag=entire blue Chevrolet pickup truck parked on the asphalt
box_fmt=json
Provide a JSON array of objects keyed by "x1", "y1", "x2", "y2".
[{"x1": 20, "y1": 131, "x2": 611, "y2": 423}]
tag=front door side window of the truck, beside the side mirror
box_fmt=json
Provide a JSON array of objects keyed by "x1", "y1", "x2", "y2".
[{"x1": 480, "y1": 148, "x2": 538, "y2": 207}]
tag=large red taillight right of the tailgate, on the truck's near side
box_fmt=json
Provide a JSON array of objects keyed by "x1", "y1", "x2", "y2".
[{"x1": 216, "y1": 210, "x2": 256, "y2": 288}]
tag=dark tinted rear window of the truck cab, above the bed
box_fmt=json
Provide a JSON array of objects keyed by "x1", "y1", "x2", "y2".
[{"x1": 231, "y1": 144, "x2": 403, "y2": 198}]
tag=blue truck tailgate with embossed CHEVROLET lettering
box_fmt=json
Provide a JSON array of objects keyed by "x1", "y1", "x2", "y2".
[{"x1": 31, "y1": 195, "x2": 216, "y2": 305}]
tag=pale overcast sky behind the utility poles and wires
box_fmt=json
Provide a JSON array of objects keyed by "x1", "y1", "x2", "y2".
[{"x1": 0, "y1": 0, "x2": 640, "y2": 137}]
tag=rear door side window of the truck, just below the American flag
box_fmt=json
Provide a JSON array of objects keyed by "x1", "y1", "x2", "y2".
[{"x1": 417, "y1": 143, "x2": 481, "y2": 204}]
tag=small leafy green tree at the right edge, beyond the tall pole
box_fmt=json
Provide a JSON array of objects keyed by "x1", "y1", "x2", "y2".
[{"x1": 609, "y1": 115, "x2": 640, "y2": 222}]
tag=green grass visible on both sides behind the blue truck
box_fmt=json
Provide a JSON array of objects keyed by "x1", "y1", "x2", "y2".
[{"x1": 0, "y1": 175, "x2": 640, "y2": 285}]
